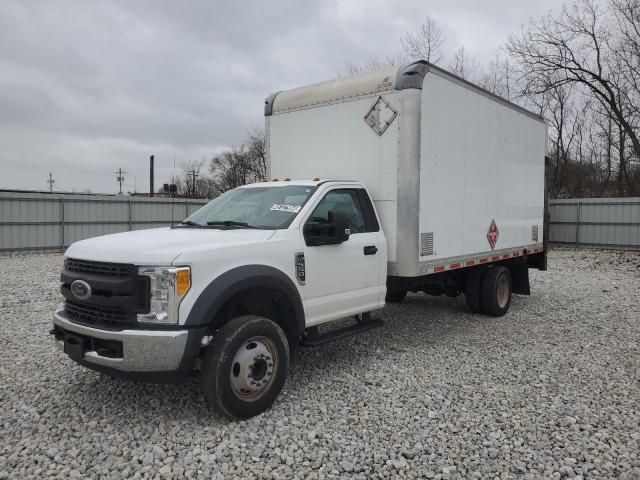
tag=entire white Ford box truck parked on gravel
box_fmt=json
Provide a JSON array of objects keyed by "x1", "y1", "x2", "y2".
[{"x1": 52, "y1": 61, "x2": 547, "y2": 418}]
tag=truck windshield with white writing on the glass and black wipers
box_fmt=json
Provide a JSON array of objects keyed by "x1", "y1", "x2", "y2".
[{"x1": 182, "y1": 185, "x2": 316, "y2": 230}]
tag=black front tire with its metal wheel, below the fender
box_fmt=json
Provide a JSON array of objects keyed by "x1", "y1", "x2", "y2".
[{"x1": 201, "y1": 315, "x2": 289, "y2": 418}]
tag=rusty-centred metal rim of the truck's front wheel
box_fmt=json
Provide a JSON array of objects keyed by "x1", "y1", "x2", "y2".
[{"x1": 229, "y1": 337, "x2": 278, "y2": 402}]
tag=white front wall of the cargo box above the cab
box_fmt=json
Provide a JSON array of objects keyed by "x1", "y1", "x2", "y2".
[{"x1": 266, "y1": 92, "x2": 402, "y2": 261}]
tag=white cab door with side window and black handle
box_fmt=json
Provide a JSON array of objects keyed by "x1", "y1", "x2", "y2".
[{"x1": 302, "y1": 188, "x2": 384, "y2": 326}]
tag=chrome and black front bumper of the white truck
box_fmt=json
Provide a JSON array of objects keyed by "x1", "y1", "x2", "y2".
[{"x1": 51, "y1": 304, "x2": 205, "y2": 383}]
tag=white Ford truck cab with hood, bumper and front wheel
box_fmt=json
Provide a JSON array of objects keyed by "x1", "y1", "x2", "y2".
[{"x1": 52, "y1": 179, "x2": 387, "y2": 417}]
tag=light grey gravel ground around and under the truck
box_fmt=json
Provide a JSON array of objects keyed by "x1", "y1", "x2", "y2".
[{"x1": 0, "y1": 250, "x2": 640, "y2": 479}]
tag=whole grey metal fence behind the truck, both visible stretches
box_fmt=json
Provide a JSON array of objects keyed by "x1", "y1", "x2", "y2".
[{"x1": 0, "y1": 192, "x2": 640, "y2": 252}]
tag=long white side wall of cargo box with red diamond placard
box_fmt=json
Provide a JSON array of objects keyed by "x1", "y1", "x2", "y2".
[{"x1": 420, "y1": 74, "x2": 546, "y2": 264}]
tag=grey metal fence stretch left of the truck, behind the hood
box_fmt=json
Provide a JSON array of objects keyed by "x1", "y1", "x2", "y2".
[{"x1": 0, "y1": 192, "x2": 207, "y2": 252}]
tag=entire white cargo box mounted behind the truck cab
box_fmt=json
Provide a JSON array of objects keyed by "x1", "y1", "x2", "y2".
[{"x1": 265, "y1": 61, "x2": 546, "y2": 277}]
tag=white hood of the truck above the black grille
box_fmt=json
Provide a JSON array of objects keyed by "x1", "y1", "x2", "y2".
[{"x1": 65, "y1": 227, "x2": 275, "y2": 265}]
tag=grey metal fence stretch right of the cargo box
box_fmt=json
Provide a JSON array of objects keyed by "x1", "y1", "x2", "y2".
[{"x1": 549, "y1": 198, "x2": 640, "y2": 249}]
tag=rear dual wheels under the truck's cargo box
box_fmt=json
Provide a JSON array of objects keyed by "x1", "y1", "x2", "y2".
[{"x1": 465, "y1": 265, "x2": 512, "y2": 317}]
